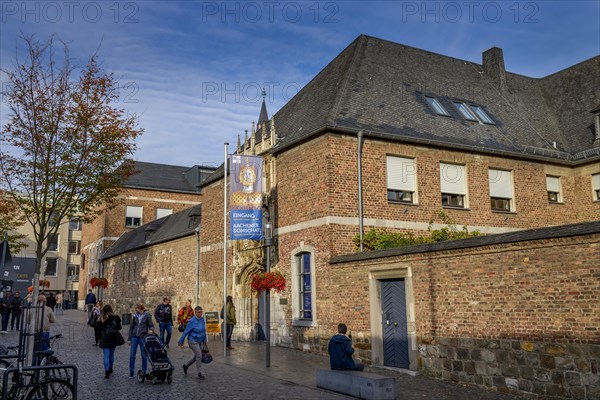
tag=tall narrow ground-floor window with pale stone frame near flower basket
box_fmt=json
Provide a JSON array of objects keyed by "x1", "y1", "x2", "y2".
[{"x1": 292, "y1": 246, "x2": 316, "y2": 326}]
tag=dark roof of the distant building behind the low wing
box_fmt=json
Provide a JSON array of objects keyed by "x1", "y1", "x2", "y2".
[{"x1": 123, "y1": 161, "x2": 198, "y2": 193}]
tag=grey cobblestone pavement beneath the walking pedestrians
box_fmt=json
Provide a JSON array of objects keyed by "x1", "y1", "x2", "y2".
[{"x1": 0, "y1": 310, "x2": 515, "y2": 400}]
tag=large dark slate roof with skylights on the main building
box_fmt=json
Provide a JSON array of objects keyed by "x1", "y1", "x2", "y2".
[{"x1": 274, "y1": 35, "x2": 600, "y2": 161}]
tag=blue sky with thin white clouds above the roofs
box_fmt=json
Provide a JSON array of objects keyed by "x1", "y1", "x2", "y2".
[{"x1": 0, "y1": 0, "x2": 600, "y2": 166}]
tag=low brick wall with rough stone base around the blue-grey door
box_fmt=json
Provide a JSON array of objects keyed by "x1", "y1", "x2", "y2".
[{"x1": 330, "y1": 233, "x2": 600, "y2": 399}]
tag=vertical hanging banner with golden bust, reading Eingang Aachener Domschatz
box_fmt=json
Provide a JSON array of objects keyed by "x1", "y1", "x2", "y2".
[{"x1": 229, "y1": 155, "x2": 264, "y2": 240}]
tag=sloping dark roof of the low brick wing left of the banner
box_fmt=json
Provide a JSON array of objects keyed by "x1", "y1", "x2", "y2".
[{"x1": 100, "y1": 204, "x2": 202, "y2": 260}]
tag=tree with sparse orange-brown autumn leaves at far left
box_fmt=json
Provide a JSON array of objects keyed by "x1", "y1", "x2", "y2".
[{"x1": 0, "y1": 36, "x2": 142, "y2": 284}]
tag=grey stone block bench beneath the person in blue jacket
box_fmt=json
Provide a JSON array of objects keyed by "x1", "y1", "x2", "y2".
[{"x1": 317, "y1": 368, "x2": 396, "y2": 400}]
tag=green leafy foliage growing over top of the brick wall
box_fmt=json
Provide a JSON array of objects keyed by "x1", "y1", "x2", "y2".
[{"x1": 353, "y1": 210, "x2": 480, "y2": 251}]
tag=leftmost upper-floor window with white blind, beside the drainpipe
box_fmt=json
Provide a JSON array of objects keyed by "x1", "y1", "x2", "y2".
[{"x1": 386, "y1": 156, "x2": 417, "y2": 204}]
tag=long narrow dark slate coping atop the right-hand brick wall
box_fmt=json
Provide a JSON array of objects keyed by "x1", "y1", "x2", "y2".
[{"x1": 329, "y1": 221, "x2": 600, "y2": 264}]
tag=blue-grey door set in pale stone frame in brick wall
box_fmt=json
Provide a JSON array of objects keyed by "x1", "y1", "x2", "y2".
[{"x1": 381, "y1": 279, "x2": 410, "y2": 368}]
